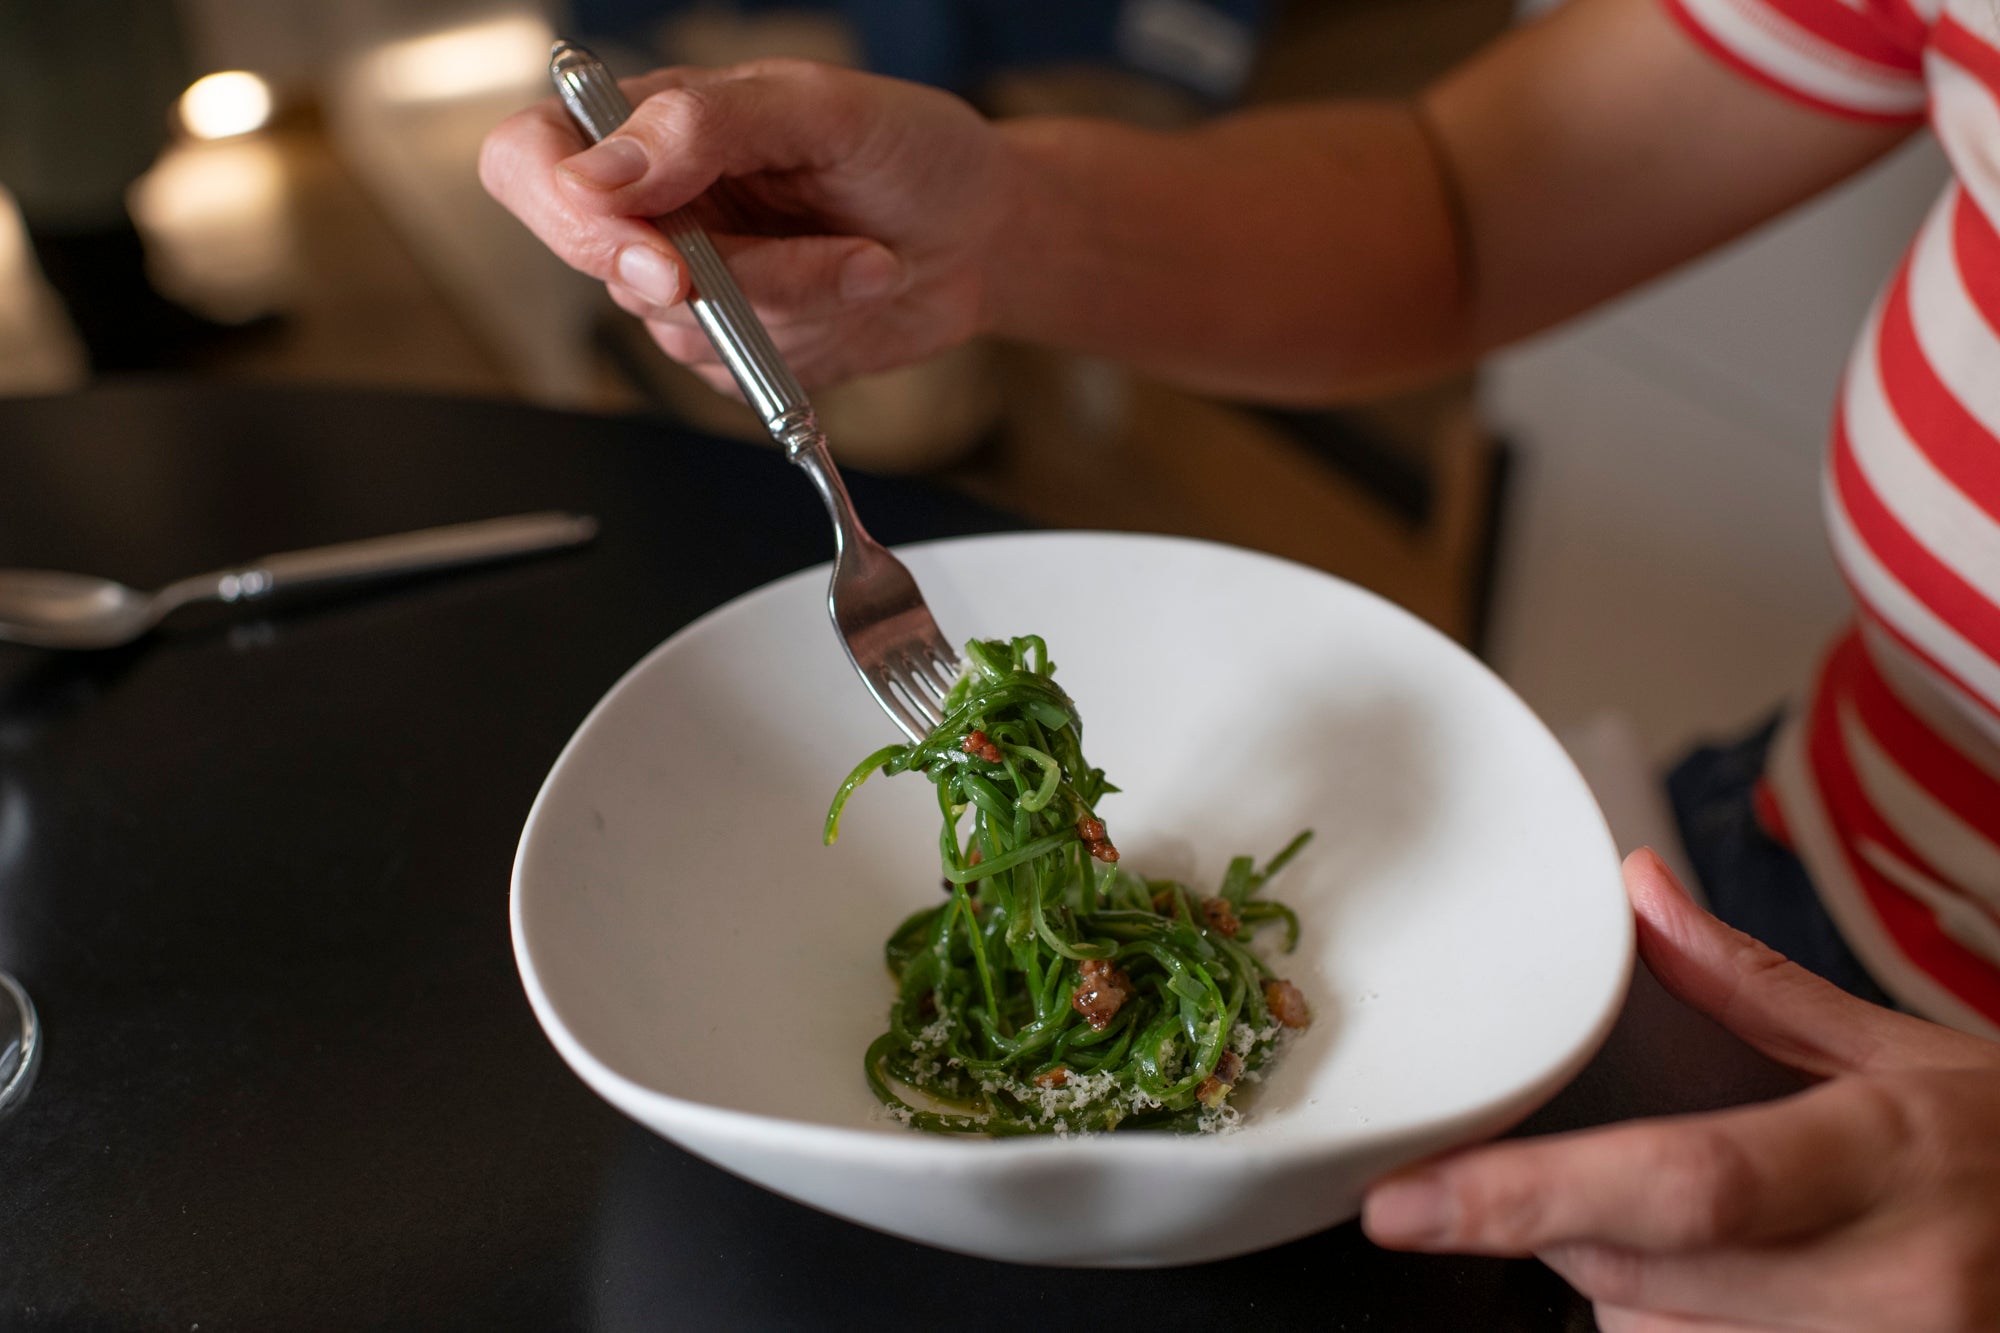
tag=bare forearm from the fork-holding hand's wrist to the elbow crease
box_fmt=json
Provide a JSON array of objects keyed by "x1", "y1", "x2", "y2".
[{"x1": 982, "y1": 102, "x2": 1472, "y2": 402}]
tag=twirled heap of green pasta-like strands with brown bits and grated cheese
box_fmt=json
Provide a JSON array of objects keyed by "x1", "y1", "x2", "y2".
[{"x1": 826, "y1": 636, "x2": 1312, "y2": 1135}]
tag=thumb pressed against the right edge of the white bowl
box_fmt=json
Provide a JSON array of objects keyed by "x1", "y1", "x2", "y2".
[{"x1": 1624, "y1": 849, "x2": 1984, "y2": 1077}]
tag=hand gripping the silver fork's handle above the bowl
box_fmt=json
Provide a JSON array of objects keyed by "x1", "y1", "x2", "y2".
[{"x1": 480, "y1": 60, "x2": 1014, "y2": 388}]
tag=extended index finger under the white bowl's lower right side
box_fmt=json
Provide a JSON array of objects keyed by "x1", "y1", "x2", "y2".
[{"x1": 1362, "y1": 1079, "x2": 1902, "y2": 1255}]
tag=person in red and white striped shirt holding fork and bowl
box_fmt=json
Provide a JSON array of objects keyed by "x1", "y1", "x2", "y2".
[{"x1": 482, "y1": 0, "x2": 2000, "y2": 1333}]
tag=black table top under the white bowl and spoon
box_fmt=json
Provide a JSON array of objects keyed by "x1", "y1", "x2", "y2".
[{"x1": 0, "y1": 380, "x2": 1790, "y2": 1333}]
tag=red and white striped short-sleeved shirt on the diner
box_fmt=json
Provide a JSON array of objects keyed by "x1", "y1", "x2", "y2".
[{"x1": 1666, "y1": 0, "x2": 2000, "y2": 1037}]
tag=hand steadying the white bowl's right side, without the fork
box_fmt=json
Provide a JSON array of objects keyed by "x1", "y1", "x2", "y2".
[{"x1": 1362, "y1": 851, "x2": 2000, "y2": 1333}]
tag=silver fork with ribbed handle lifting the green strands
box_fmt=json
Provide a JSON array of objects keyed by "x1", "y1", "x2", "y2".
[{"x1": 548, "y1": 42, "x2": 958, "y2": 741}]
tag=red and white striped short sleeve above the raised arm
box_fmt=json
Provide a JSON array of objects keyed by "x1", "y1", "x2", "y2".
[{"x1": 1664, "y1": 0, "x2": 1930, "y2": 124}]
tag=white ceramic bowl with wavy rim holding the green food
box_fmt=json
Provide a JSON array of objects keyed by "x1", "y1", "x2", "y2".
[{"x1": 512, "y1": 532, "x2": 1632, "y2": 1267}]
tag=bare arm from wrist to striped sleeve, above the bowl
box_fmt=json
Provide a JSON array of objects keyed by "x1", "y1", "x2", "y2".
[{"x1": 986, "y1": 0, "x2": 1908, "y2": 402}]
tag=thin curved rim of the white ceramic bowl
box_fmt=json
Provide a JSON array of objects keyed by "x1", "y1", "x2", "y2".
[{"x1": 508, "y1": 528, "x2": 1638, "y2": 1171}]
